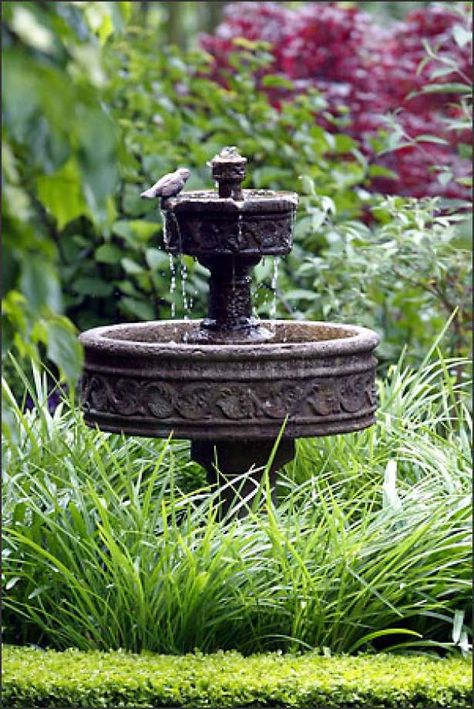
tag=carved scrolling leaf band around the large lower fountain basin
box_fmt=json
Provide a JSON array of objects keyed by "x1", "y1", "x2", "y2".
[{"x1": 82, "y1": 371, "x2": 376, "y2": 422}]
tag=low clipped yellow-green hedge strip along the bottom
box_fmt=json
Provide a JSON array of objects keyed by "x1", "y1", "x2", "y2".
[{"x1": 3, "y1": 646, "x2": 471, "y2": 709}]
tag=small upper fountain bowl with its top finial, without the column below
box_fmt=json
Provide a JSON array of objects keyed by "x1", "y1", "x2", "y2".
[{"x1": 163, "y1": 148, "x2": 298, "y2": 260}]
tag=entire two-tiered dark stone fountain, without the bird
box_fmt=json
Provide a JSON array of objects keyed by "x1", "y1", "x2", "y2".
[{"x1": 80, "y1": 148, "x2": 378, "y2": 504}]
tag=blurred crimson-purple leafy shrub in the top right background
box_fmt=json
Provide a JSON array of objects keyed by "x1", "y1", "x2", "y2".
[{"x1": 201, "y1": 2, "x2": 471, "y2": 199}]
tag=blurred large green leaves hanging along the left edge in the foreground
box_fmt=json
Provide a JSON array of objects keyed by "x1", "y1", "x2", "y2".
[{"x1": 2, "y1": 2, "x2": 130, "y2": 380}]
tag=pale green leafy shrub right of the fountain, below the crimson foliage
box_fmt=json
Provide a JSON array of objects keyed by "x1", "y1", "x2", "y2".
[{"x1": 286, "y1": 192, "x2": 472, "y2": 364}]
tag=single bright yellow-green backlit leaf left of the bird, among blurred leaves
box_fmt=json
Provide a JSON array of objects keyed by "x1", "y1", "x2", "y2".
[{"x1": 36, "y1": 158, "x2": 88, "y2": 229}]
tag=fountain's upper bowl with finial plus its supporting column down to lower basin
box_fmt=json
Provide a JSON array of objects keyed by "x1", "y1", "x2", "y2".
[{"x1": 162, "y1": 147, "x2": 298, "y2": 344}]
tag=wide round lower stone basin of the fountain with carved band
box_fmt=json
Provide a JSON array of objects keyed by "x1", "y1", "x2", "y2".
[{"x1": 80, "y1": 320, "x2": 379, "y2": 442}]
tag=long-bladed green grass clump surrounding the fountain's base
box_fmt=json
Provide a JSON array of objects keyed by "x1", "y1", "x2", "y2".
[{"x1": 4, "y1": 340, "x2": 471, "y2": 653}]
